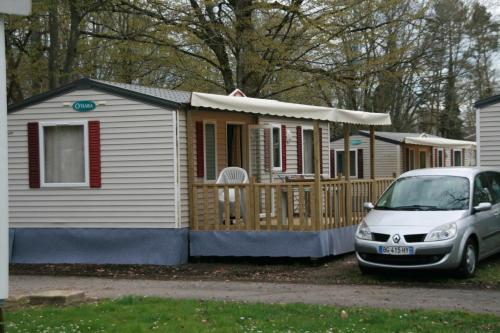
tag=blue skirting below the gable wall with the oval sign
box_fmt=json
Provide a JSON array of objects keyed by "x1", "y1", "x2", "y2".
[{"x1": 9, "y1": 228, "x2": 189, "y2": 265}]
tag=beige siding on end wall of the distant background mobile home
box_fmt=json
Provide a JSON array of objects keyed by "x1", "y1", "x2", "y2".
[{"x1": 330, "y1": 135, "x2": 400, "y2": 178}]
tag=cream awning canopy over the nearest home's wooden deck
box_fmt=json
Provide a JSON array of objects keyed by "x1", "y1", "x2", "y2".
[{"x1": 191, "y1": 92, "x2": 391, "y2": 125}]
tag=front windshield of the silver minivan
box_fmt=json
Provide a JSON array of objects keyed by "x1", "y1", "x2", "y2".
[{"x1": 375, "y1": 176, "x2": 469, "y2": 210}]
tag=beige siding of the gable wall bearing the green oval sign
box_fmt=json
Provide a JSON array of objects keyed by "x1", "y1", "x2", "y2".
[{"x1": 8, "y1": 90, "x2": 176, "y2": 228}]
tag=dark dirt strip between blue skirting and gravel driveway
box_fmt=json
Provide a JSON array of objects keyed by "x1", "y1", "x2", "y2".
[{"x1": 10, "y1": 254, "x2": 500, "y2": 289}]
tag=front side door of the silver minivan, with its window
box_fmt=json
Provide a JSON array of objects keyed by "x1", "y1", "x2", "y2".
[{"x1": 472, "y1": 172, "x2": 496, "y2": 254}]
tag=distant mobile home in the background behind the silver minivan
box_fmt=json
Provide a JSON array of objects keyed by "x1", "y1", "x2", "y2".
[{"x1": 330, "y1": 131, "x2": 476, "y2": 179}]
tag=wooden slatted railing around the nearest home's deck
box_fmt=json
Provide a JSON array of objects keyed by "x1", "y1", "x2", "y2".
[{"x1": 191, "y1": 178, "x2": 393, "y2": 231}]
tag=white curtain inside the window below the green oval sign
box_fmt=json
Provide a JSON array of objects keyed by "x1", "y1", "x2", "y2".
[{"x1": 43, "y1": 125, "x2": 85, "y2": 183}]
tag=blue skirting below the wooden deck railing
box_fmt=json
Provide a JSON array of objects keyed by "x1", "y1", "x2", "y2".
[{"x1": 189, "y1": 226, "x2": 356, "y2": 258}]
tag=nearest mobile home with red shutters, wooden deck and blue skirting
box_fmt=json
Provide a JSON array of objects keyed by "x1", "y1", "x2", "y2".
[{"x1": 8, "y1": 79, "x2": 390, "y2": 265}]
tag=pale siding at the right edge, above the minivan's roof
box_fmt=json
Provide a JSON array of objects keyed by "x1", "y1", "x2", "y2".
[{"x1": 477, "y1": 103, "x2": 500, "y2": 167}]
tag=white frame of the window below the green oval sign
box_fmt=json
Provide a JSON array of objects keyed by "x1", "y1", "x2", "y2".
[{"x1": 38, "y1": 120, "x2": 90, "y2": 188}]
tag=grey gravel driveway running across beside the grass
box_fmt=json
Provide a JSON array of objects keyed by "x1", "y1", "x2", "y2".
[{"x1": 10, "y1": 275, "x2": 500, "y2": 315}]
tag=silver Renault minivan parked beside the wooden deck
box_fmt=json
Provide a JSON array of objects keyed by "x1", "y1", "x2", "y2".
[{"x1": 355, "y1": 168, "x2": 500, "y2": 277}]
